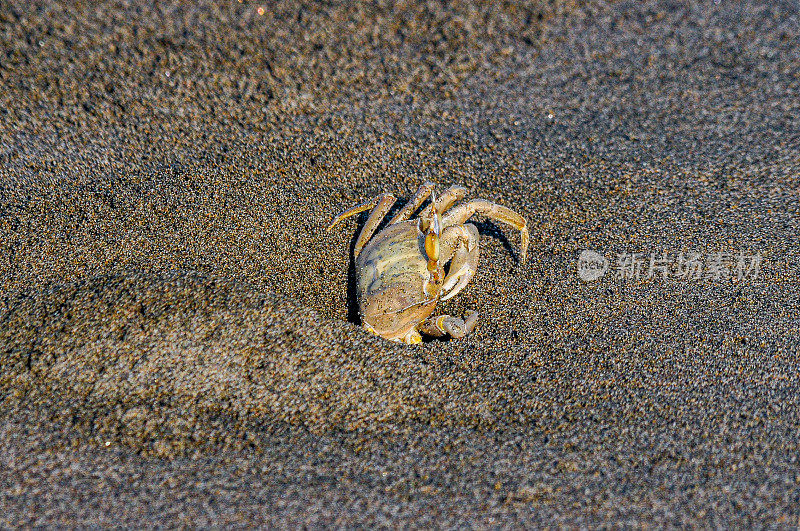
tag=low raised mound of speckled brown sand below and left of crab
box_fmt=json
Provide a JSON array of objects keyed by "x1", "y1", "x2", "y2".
[{"x1": 0, "y1": 271, "x2": 552, "y2": 453}]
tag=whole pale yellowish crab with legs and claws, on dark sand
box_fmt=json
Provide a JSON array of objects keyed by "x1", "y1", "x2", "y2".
[{"x1": 327, "y1": 182, "x2": 530, "y2": 344}]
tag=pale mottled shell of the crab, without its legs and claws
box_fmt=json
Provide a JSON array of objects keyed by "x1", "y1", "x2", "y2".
[{"x1": 356, "y1": 219, "x2": 444, "y2": 340}]
